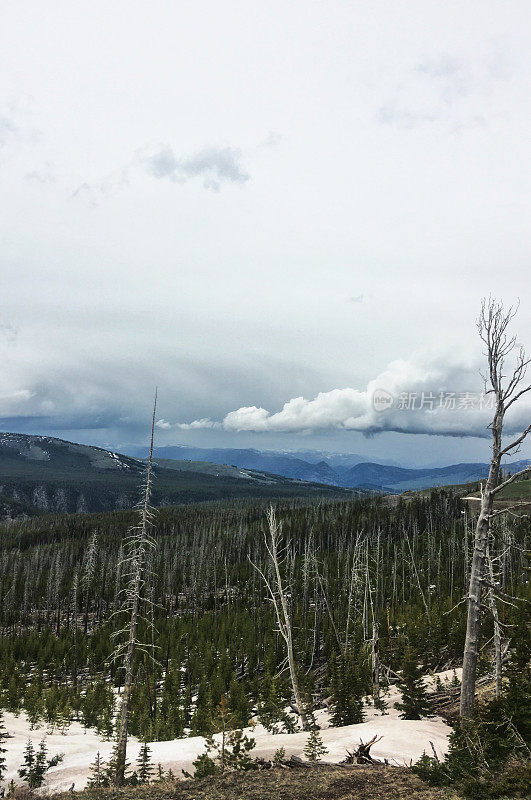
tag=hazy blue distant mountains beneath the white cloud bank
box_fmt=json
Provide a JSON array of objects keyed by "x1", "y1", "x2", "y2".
[{"x1": 123, "y1": 445, "x2": 530, "y2": 493}]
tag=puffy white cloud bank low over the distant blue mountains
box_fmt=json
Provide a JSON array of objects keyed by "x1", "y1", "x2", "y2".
[{"x1": 170, "y1": 358, "x2": 531, "y2": 437}]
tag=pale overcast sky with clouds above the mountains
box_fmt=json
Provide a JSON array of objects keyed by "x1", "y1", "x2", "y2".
[{"x1": 0, "y1": 0, "x2": 531, "y2": 465}]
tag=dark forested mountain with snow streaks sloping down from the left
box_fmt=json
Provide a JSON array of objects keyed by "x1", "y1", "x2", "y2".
[{"x1": 0, "y1": 433, "x2": 360, "y2": 518}]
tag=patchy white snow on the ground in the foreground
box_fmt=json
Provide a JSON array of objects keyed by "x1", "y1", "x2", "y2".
[{"x1": 4, "y1": 670, "x2": 460, "y2": 791}]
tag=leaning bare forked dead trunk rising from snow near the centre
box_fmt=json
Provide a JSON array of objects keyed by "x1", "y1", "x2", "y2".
[{"x1": 251, "y1": 506, "x2": 310, "y2": 731}]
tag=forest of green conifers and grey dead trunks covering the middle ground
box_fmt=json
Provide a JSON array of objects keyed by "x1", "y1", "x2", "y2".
[{"x1": 0, "y1": 491, "x2": 529, "y2": 740}]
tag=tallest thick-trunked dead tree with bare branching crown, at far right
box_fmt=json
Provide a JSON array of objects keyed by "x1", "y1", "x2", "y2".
[{"x1": 460, "y1": 299, "x2": 531, "y2": 717}]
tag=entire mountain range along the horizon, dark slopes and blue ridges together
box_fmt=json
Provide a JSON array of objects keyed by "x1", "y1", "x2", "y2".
[{"x1": 0, "y1": 433, "x2": 530, "y2": 518}]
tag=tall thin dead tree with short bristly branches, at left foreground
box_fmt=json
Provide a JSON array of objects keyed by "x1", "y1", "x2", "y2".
[{"x1": 113, "y1": 393, "x2": 157, "y2": 786}]
